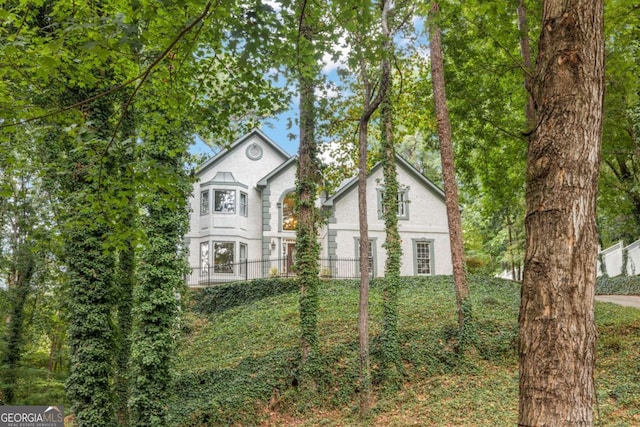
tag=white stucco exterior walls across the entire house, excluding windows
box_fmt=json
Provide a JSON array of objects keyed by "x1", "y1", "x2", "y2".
[{"x1": 187, "y1": 132, "x2": 452, "y2": 283}]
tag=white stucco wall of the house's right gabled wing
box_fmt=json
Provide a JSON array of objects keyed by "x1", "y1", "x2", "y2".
[{"x1": 322, "y1": 167, "x2": 453, "y2": 276}]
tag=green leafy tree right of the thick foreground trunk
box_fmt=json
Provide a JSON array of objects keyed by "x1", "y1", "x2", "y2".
[{"x1": 598, "y1": 0, "x2": 640, "y2": 247}]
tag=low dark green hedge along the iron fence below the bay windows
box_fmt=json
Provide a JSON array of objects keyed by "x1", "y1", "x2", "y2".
[{"x1": 191, "y1": 278, "x2": 298, "y2": 315}]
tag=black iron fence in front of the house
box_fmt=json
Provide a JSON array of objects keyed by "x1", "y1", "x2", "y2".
[{"x1": 185, "y1": 258, "x2": 360, "y2": 287}]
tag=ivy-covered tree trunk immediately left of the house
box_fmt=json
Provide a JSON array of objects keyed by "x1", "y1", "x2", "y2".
[{"x1": 129, "y1": 111, "x2": 192, "y2": 427}]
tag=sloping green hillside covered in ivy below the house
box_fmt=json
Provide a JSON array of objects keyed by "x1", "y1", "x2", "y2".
[{"x1": 169, "y1": 278, "x2": 640, "y2": 427}]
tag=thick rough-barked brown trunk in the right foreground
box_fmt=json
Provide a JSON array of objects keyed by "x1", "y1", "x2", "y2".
[{"x1": 518, "y1": 0, "x2": 604, "y2": 426}]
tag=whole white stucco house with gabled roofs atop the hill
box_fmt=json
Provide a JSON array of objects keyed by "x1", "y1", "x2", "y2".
[{"x1": 187, "y1": 130, "x2": 452, "y2": 285}]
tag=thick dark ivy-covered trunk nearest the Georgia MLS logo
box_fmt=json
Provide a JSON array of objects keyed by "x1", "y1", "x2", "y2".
[{"x1": 61, "y1": 88, "x2": 116, "y2": 427}]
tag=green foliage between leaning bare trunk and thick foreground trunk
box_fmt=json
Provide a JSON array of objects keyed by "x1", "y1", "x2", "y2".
[{"x1": 430, "y1": 0, "x2": 537, "y2": 276}]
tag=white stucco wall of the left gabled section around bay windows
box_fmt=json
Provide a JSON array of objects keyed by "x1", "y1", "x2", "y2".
[{"x1": 187, "y1": 134, "x2": 290, "y2": 267}]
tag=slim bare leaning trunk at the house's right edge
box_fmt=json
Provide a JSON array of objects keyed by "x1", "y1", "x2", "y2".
[{"x1": 429, "y1": 2, "x2": 471, "y2": 337}]
